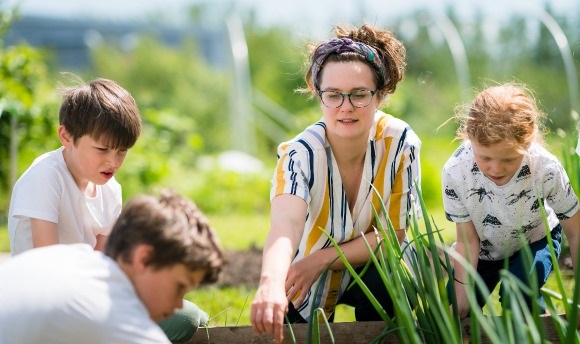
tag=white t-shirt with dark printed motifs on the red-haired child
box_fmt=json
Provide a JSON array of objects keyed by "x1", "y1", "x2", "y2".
[{"x1": 442, "y1": 141, "x2": 579, "y2": 260}]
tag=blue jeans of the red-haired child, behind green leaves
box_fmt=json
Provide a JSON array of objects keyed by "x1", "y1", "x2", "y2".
[{"x1": 447, "y1": 225, "x2": 562, "y2": 313}]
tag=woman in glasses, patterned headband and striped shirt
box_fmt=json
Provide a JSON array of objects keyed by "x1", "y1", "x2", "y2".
[{"x1": 251, "y1": 25, "x2": 421, "y2": 342}]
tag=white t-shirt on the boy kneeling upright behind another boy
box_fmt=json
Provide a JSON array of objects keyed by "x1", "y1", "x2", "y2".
[{"x1": 8, "y1": 147, "x2": 122, "y2": 255}]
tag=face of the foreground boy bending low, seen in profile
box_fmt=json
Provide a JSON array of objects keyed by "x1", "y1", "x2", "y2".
[{"x1": 133, "y1": 264, "x2": 205, "y2": 322}]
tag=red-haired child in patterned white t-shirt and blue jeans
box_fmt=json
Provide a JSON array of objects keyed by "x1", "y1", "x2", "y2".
[{"x1": 442, "y1": 83, "x2": 580, "y2": 317}]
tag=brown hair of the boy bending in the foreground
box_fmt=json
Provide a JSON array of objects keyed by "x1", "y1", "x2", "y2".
[{"x1": 105, "y1": 190, "x2": 224, "y2": 283}]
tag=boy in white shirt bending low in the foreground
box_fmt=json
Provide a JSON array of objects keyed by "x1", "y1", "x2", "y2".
[{"x1": 0, "y1": 192, "x2": 224, "y2": 344}]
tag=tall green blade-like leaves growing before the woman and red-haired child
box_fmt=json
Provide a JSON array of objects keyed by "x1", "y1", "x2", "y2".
[{"x1": 311, "y1": 184, "x2": 580, "y2": 343}]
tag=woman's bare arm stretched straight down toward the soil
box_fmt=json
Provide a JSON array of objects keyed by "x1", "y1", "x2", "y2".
[{"x1": 251, "y1": 194, "x2": 307, "y2": 343}]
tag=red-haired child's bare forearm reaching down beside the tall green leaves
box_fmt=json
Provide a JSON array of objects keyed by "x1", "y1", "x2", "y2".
[{"x1": 453, "y1": 221, "x2": 480, "y2": 319}]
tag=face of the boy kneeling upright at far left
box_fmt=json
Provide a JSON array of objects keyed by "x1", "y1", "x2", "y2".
[{"x1": 59, "y1": 127, "x2": 127, "y2": 189}]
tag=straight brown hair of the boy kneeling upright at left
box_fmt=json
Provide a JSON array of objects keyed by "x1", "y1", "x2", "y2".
[{"x1": 59, "y1": 78, "x2": 141, "y2": 149}]
